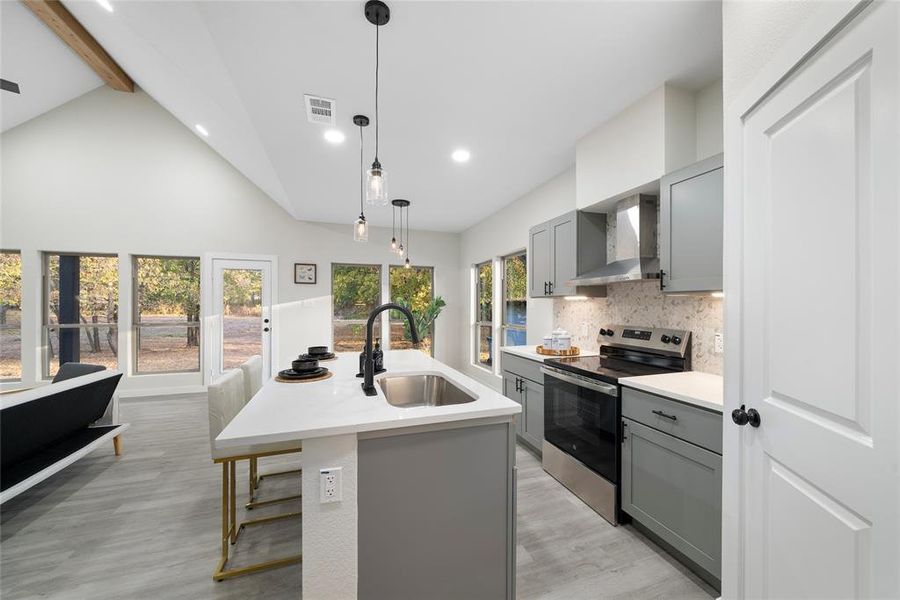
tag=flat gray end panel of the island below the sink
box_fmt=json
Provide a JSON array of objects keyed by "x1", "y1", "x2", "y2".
[{"x1": 357, "y1": 418, "x2": 516, "y2": 600}]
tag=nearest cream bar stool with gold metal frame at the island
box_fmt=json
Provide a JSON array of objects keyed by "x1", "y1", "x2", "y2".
[{"x1": 208, "y1": 369, "x2": 303, "y2": 581}]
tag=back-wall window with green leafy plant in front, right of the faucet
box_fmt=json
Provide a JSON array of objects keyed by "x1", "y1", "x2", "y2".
[{"x1": 389, "y1": 265, "x2": 445, "y2": 356}]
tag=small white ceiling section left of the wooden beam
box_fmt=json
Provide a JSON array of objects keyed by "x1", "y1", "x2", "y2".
[{"x1": 0, "y1": 1, "x2": 103, "y2": 131}]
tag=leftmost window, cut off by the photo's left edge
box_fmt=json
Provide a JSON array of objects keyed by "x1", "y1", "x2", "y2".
[{"x1": 0, "y1": 250, "x2": 22, "y2": 381}]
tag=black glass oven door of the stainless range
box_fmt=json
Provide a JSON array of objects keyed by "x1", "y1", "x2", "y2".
[{"x1": 541, "y1": 367, "x2": 619, "y2": 484}]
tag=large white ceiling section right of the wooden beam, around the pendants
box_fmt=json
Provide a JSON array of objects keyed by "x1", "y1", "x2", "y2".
[{"x1": 15, "y1": 0, "x2": 721, "y2": 231}]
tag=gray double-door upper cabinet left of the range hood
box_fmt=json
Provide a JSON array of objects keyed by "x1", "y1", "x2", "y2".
[{"x1": 528, "y1": 210, "x2": 606, "y2": 298}]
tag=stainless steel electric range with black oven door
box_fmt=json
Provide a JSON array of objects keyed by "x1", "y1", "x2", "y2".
[{"x1": 541, "y1": 325, "x2": 691, "y2": 525}]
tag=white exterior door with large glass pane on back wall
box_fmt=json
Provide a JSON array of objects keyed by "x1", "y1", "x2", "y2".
[{"x1": 208, "y1": 258, "x2": 273, "y2": 377}]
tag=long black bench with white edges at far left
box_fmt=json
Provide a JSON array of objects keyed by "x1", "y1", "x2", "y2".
[{"x1": 0, "y1": 371, "x2": 128, "y2": 504}]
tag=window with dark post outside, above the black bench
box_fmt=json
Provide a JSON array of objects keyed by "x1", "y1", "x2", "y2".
[{"x1": 43, "y1": 254, "x2": 119, "y2": 377}]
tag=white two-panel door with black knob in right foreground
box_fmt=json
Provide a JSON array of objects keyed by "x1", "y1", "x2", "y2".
[{"x1": 723, "y1": 2, "x2": 900, "y2": 599}]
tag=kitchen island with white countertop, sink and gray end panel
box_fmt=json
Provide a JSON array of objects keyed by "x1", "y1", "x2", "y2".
[{"x1": 216, "y1": 350, "x2": 521, "y2": 599}]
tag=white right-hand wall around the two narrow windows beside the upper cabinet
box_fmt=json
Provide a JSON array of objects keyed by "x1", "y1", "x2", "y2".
[{"x1": 459, "y1": 167, "x2": 575, "y2": 389}]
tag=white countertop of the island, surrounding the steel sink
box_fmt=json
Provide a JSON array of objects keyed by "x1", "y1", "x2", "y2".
[{"x1": 216, "y1": 350, "x2": 522, "y2": 448}]
